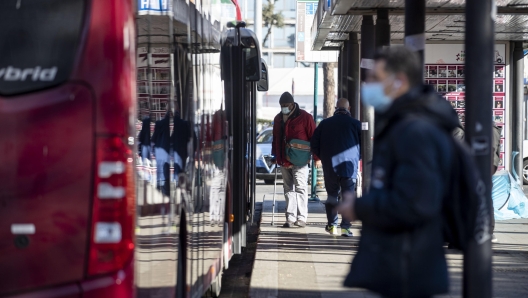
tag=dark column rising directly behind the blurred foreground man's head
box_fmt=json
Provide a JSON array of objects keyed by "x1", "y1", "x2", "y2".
[{"x1": 406, "y1": 0, "x2": 425, "y2": 78}]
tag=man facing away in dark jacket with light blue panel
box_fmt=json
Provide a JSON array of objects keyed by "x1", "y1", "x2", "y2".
[{"x1": 310, "y1": 98, "x2": 361, "y2": 237}]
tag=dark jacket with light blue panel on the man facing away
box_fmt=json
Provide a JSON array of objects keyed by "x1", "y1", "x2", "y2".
[{"x1": 310, "y1": 111, "x2": 361, "y2": 179}]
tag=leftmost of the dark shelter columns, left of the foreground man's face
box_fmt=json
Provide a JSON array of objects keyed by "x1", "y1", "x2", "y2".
[{"x1": 347, "y1": 32, "x2": 361, "y2": 119}]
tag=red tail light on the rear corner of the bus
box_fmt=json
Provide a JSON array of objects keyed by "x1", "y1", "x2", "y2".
[{"x1": 88, "y1": 137, "x2": 135, "y2": 275}]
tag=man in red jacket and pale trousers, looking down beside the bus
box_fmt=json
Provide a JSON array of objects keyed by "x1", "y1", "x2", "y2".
[{"x1": 271, "y1": 92, "x2": 321, "y2": 228}]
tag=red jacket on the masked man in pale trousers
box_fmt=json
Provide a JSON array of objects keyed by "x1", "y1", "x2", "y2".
[{"x1": 271, "y1": 104, "x2": 319, "y2": 167}]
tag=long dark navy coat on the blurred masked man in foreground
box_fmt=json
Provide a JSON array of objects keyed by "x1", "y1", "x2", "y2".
[{"x1": 345, "y1": 87, "x2": 459, "y2": 297}]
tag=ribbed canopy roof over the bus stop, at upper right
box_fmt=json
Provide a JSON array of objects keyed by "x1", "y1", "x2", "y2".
[{"x1": 312, "y1": 0, "x2": 528, "y2": 50}]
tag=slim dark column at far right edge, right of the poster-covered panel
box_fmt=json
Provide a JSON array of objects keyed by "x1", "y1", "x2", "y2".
[{"x1": 510, "y1": 41, "x2": 524, "y2": 183}]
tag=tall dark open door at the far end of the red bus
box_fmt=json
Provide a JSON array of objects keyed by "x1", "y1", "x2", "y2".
[{"x1": 221, "y1": 22, "x2": 267, "y2": 254}]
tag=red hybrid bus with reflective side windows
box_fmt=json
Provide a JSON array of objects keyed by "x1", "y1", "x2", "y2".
[{"x1": 0, "y1": 0, "x2": 266, "y2": 297}]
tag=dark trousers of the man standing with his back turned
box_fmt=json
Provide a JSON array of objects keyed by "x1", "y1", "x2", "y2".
[{"x1": 324, "y1": 169, "x2": 356, "y2": 229}]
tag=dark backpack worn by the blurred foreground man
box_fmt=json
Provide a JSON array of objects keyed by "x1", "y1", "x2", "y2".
[{"x1": 443, "y1": 139, "x2": 491, "y2": 252}]
